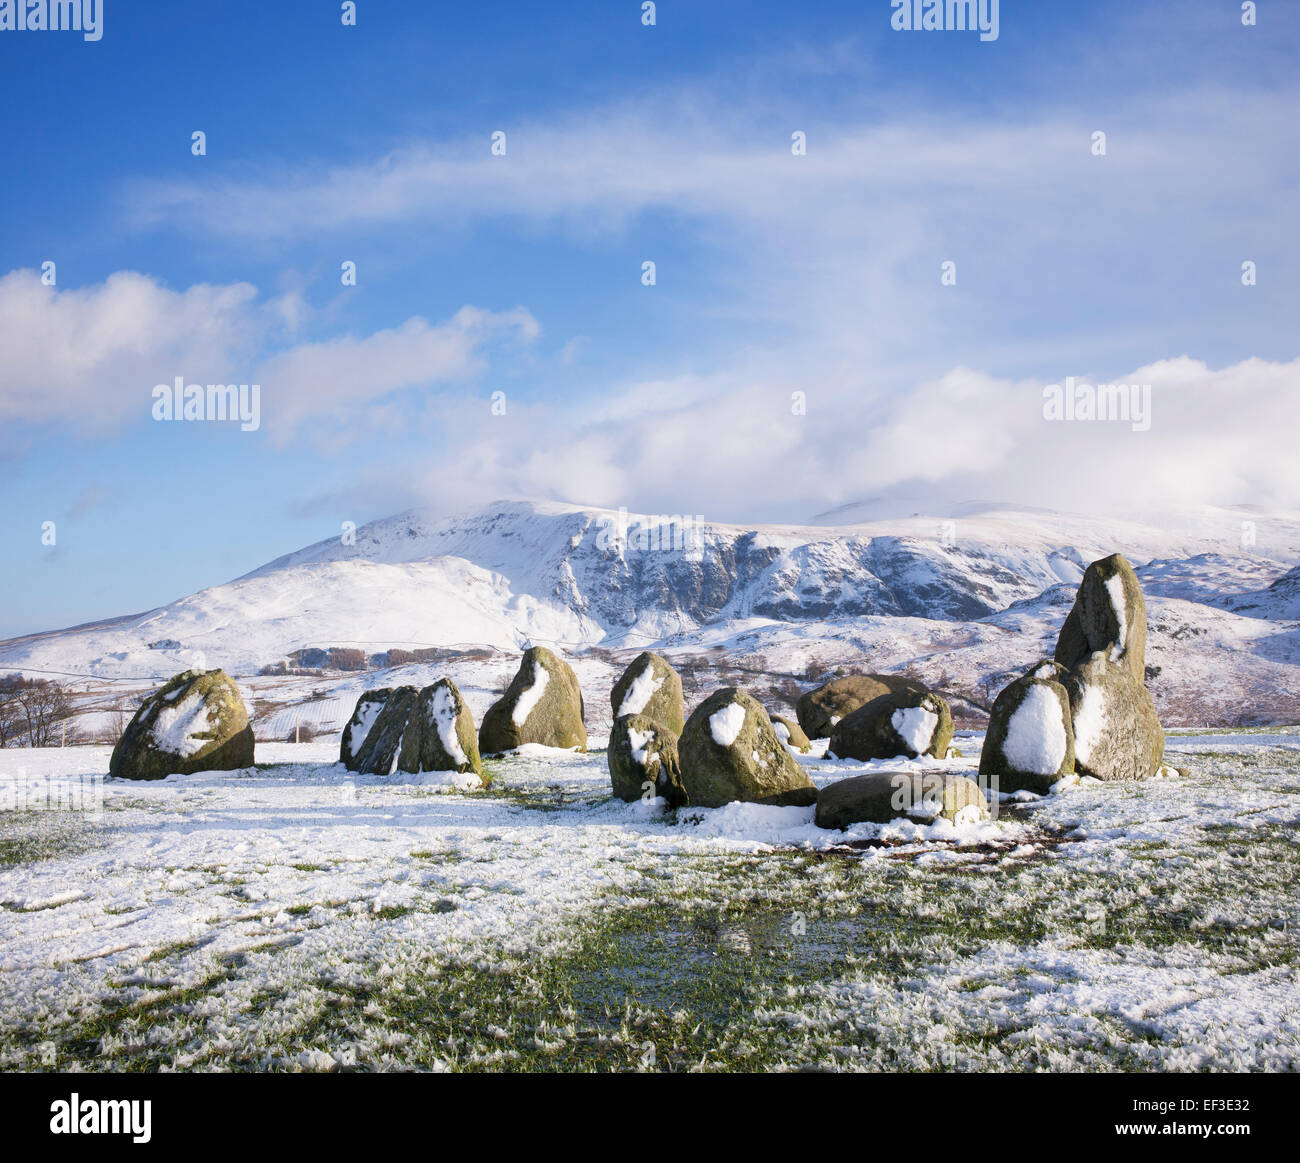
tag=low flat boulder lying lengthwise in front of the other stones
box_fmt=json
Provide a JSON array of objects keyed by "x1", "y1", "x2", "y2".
[{"x1": 815, "y1": 772, "x2": 989, "y2": 828}]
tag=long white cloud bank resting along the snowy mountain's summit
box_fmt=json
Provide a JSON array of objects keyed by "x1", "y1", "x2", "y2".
[{"x1": 385, "y1": 357, "x2": 1300, "y2": 521}]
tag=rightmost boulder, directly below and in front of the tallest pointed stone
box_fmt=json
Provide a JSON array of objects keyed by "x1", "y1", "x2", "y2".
[{"x1": 1063, "y1": 650, "x2": 1165, "y2": 782}]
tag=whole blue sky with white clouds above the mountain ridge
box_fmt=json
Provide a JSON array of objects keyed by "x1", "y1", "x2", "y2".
[{"x1": 0, "y1": 0, "x2": 1300, "y2": 634}]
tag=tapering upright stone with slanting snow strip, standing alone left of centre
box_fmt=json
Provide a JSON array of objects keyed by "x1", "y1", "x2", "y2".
[{"x1": 478, "y1": 646, "x2": 586, "y2": 755}]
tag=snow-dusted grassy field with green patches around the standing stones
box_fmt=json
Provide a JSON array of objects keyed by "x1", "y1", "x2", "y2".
[{"x1": 0, "y1": 730, "x2": 1300, "y2": 1071}]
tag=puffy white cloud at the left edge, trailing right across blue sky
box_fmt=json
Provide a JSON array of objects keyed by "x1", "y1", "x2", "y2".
[{"x1": 0, "y1": 270, "x2": 541, "y2": 442}]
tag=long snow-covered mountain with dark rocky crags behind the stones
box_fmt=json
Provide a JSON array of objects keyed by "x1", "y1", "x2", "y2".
[{"x1": 0, "y1": 502, "x2": 1300, "y2": 713}]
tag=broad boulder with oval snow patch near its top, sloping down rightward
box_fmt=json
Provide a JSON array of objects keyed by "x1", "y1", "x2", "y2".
[{"x1": 677, "y1": 686, "x2": 816, "y2": 808}]
